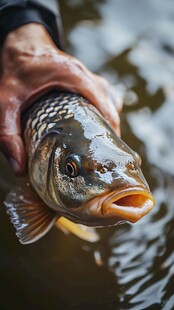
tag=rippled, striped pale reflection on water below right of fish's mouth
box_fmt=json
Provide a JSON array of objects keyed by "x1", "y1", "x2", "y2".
[{"x1": 109, "y1": 180, "x2": 174, "y2": 309}]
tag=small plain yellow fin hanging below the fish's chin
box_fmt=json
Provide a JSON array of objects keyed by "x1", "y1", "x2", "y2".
[{"x1": 56, "y1": 216, "x2": 99, "y2": 242}]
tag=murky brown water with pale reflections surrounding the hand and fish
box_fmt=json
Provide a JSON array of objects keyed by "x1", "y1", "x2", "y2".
[{"x1": 0, "y1": 0, "x2": 174, "y2": 310}]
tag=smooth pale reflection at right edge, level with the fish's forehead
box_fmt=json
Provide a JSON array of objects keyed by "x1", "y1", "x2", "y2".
[{"x1": 128, "y1": 101, "x2": 174, "y2": 176}]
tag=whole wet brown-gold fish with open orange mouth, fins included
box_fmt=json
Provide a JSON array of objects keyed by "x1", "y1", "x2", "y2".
[{"x1": 4, "y1": 90, "x2": 155, "y2": 244}]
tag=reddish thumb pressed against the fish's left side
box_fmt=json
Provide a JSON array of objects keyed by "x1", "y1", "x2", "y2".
[{"x1": 0, "y1": 104, "x2": 26, "y2": 175}]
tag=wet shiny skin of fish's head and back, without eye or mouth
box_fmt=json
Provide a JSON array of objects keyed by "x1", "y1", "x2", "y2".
[{"x1": 25, "y1": 93, "x2": 148, "y2": 210}]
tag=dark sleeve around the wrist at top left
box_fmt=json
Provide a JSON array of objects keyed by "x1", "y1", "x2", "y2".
[{"x1": 0, "y1": 0, "x2": 62, "y2": 49}]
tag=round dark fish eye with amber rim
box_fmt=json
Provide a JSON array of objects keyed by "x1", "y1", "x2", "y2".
[{"x1": 65, "y1": 154, "x2": 81, "y2": 178}]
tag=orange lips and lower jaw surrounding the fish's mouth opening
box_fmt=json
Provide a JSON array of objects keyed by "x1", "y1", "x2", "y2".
[{"x1": 61, "y1": 186, "x2": 155, "y2": 227}]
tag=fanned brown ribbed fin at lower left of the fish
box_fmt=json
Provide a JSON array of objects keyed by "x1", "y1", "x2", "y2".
[{"x1": 4, "y1": 183, "x2": 59, "y2": 244}]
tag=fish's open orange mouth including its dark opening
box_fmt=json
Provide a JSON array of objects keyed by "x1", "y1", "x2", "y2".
[{"x1": 101, "y1": 187, "x2": 155, "y2": 223}]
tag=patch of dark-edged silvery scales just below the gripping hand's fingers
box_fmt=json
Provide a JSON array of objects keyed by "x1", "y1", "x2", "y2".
[{"x1": 23, "y1": 92, "x2": 87, "y2": 155}]
